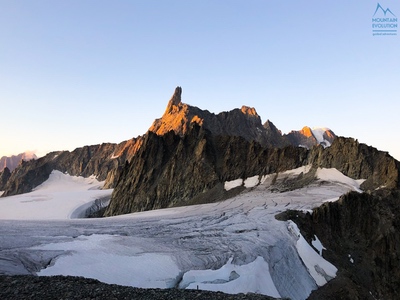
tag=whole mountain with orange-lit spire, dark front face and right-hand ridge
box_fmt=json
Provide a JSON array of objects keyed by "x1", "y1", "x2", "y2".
[{"x1": 106, "y1": 87, "x2": 400, "y2": 216}]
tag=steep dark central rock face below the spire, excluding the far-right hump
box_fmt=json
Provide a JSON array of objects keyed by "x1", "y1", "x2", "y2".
[{"x1": 105, "y1": 124, "x2": 307, "y2": 216}]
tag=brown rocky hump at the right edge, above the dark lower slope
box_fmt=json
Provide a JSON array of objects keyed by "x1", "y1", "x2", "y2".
[{"x1": 310, "y1": 137, "x2": 400, "y2": 190}]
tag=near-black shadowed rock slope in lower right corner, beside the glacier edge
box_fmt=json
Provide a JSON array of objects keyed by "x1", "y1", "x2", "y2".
[{"x1": 294, "y1": 190, "x2": 400, "y2": 299}]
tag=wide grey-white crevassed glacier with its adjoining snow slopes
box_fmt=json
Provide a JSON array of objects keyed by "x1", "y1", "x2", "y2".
[{"x1": 0, "y1": 167, "x2": 364, "y2": 299}]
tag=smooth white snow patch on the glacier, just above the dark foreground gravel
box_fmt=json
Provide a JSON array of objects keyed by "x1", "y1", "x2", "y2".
[{"x1": 32, "y1": 234, "x2": 180, "y2": 288}]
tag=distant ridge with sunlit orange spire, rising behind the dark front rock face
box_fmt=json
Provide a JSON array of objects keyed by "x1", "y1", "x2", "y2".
[{"x1": 2, "y1": 87, "x2": 334, "y2": 196}]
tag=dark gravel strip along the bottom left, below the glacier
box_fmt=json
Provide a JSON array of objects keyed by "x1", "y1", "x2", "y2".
[{"x1": 0, "y1": 275, "x2": 275, "y2": 300}]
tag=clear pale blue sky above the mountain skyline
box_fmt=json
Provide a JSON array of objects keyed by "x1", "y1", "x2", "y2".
[{"x1": 0, "y1": 0, "x2": 400, "y2": 160}]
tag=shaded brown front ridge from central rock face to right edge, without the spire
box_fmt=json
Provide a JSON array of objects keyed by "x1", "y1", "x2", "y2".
[{"x1": 105, "y1": 130, "x2": 399, "y2": 216}]
